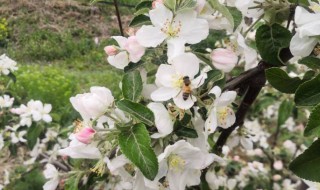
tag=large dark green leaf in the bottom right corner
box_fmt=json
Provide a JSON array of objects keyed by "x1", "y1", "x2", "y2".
[{"x1": 289, "y1": 140, "x2": 320, "y2": 182}]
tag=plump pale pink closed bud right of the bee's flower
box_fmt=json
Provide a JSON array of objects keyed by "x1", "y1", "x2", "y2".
[{"x1": 211, "y1": 48, "x2": 238, "y2": 73}]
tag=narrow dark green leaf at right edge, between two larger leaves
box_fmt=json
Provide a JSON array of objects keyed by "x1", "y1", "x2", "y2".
[{"x1": 304, "y1": 104, "x2": 320, "y2": 137}]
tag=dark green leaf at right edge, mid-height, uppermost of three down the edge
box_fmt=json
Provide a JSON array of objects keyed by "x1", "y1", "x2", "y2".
[{"x1": 294, "y1": 75, "x2": 320, "y2": 106}]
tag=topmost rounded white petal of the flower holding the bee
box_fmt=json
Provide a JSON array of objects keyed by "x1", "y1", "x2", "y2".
[{"x1": 172, "y1": 53, "x2": 200, "y2": 80}]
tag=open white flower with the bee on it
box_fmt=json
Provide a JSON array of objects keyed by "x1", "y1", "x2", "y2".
[{"x1": 151, "y1": 53, "x2": 207, "y2": 109}]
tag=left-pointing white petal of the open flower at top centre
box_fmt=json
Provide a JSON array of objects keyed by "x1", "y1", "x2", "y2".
[{"x1": 136, "y1": 26, "x2": 167, "y2": 47}]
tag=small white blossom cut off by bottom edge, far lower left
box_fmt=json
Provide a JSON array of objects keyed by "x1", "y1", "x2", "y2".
[{"x1": 43, "y1": 164, "x2": 59, "y2": 190}]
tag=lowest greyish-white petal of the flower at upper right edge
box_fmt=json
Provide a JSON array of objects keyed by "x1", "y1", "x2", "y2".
[{"x1": 290, "y1": 33, "x2": 318, "y2": 57}]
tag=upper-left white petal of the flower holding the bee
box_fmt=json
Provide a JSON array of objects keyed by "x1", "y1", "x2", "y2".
[{"x1": 156, "y1": 64, "x2": 177, "y2": 87}]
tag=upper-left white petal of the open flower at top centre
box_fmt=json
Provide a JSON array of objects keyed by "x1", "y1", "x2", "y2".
[{"x1": 149, "y1": 4, "x2": 173, "y2": 27}]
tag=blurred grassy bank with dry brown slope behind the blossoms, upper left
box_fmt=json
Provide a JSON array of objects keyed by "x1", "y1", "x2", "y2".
[{"x1": 0, "y1": 0, "x2": 139, "y2": 126}]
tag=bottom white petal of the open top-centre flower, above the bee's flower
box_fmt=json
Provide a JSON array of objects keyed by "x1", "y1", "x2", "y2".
[{"x1": 167, "y1": 38, "x2": 186, "y2": 63}]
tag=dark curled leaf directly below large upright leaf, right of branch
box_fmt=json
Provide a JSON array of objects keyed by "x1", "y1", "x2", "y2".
[{"x1": 266, "y1": 67, "x2": 304, "y2": 94}]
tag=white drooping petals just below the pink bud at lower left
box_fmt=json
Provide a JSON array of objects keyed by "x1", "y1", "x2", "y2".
[{"x1": 58, "y1": 134, "x2": 101, "y2": 159}]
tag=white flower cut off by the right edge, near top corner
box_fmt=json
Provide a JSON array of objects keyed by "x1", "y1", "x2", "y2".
[{"x1": 290, "y1": 6, "x2": 320, "y2": 57}]
